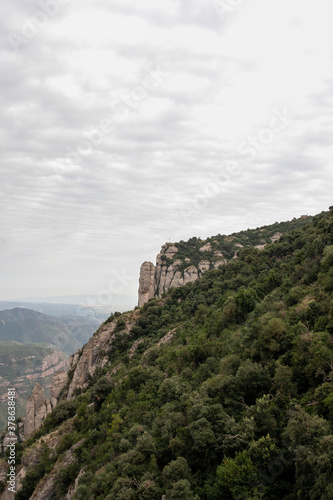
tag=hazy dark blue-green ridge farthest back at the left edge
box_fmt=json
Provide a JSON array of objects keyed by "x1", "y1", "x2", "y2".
[{"x1": 0, "y1": 307, "x2": 96, "y2": 354}]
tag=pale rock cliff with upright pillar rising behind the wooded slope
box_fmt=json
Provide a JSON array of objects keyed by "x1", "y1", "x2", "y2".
[{"x1": 138, "y1": 216, "x2": 311, "y2": 307}]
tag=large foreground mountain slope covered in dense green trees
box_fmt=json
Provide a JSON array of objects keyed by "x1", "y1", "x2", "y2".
[{"x1": 0, "y1": 207, "x2": 333, "y2": 500}]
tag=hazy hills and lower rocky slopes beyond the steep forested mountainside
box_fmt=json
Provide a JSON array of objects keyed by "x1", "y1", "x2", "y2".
[{"x1": 0, "y1": 307, "x2": 105, "y2": 431}]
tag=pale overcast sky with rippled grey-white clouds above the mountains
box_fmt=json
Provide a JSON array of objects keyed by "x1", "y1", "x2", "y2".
[{"x1": 0, "y1": 0, "x2": 333, "y2": 300}]
